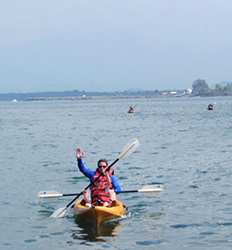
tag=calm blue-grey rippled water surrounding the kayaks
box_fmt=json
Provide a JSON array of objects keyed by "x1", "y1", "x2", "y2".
[{"x1": 0, "y1": 98, "x2": 232, "y2": 250}]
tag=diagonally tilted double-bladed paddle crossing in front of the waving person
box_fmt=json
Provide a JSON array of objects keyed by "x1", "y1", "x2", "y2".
[{"x1": 51, "y1": 139, "x2": 139, "y2": 218}]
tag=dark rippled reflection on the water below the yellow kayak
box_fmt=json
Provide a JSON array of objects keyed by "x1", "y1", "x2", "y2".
[{"x1": 72, "y1": 216, "x2": 121, "y2": 242}]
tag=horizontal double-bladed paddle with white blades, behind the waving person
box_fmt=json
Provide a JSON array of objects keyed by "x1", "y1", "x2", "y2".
[{"x1": 38, "y1": 185, "x2": 163, "y2": 198}]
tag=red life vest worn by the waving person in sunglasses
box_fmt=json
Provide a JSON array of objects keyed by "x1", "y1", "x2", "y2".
[{"x1": 91, "y1": 170, "x2": 113, "y2": 205}]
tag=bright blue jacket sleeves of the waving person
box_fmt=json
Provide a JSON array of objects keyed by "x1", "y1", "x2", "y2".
[{"x1": 77, "y1": 159, "x2": 121, "y2": 193}]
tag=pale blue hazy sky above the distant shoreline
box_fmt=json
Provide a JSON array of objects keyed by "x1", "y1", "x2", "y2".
[{"x1": 0, "y1": 0, "x2": 232, "y2": 93}]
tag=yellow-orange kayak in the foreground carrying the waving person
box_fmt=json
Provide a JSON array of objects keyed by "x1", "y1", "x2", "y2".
[{"x1": 73, "y1": 200, "x2": 127, "y2": 227}]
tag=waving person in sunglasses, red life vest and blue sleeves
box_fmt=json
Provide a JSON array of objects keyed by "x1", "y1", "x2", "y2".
[{"x1": 76, "y1": 148, "x2": 121, "y2": 206}]
